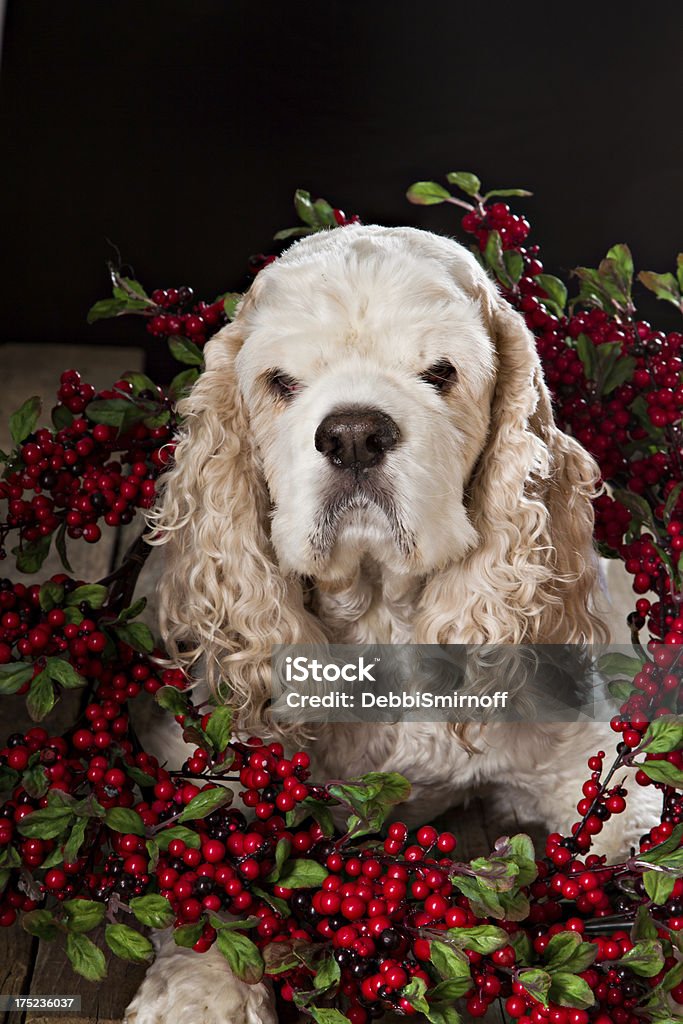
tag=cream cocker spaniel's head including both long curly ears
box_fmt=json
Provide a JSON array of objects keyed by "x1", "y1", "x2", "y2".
[{"x1": 154, "y1": 226, "x2": 610, "y2": 710}]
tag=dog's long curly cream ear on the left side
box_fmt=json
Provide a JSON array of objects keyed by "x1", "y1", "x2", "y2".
[{"x1": 150, "y1": 297, "x2": 325, "y2": 728}]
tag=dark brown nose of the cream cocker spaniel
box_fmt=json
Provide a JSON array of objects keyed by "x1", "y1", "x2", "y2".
[{"x1": 315, "y1": 409, "x2": 400, "y2": 469}]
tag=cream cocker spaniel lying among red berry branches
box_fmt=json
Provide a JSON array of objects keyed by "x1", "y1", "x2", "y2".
[{"x1": 126, "y1": 225, "x2": 663, "y2": 1024}]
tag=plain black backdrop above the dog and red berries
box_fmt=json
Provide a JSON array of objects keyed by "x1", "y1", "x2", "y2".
[{"x1": 0, "y1": 0, "x2": 683, "y2": 378}]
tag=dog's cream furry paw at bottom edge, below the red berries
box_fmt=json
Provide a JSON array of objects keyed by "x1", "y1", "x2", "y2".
[{"x1": 123, "y1": 949, "x2": 276, "y2": 1024}]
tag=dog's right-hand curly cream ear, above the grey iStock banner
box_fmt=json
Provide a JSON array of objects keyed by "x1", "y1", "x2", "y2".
[{"x1": 416, "y1": 278, "x2": 607, "y2": 643}]
